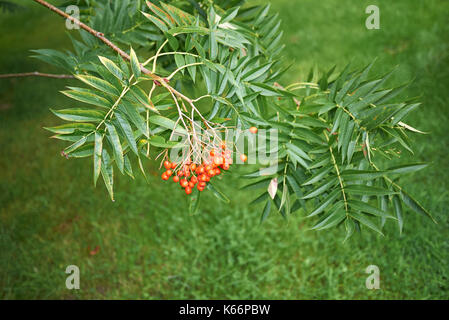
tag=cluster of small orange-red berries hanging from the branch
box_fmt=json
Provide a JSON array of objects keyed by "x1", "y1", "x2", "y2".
[{"x1": 162, "y1": 144, "x2": 246, "y2": 194}]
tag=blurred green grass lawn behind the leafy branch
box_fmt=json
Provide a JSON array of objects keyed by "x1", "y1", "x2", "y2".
[{"x1": 0, "y1": 0, "x2": 449, "y2": 299}]
